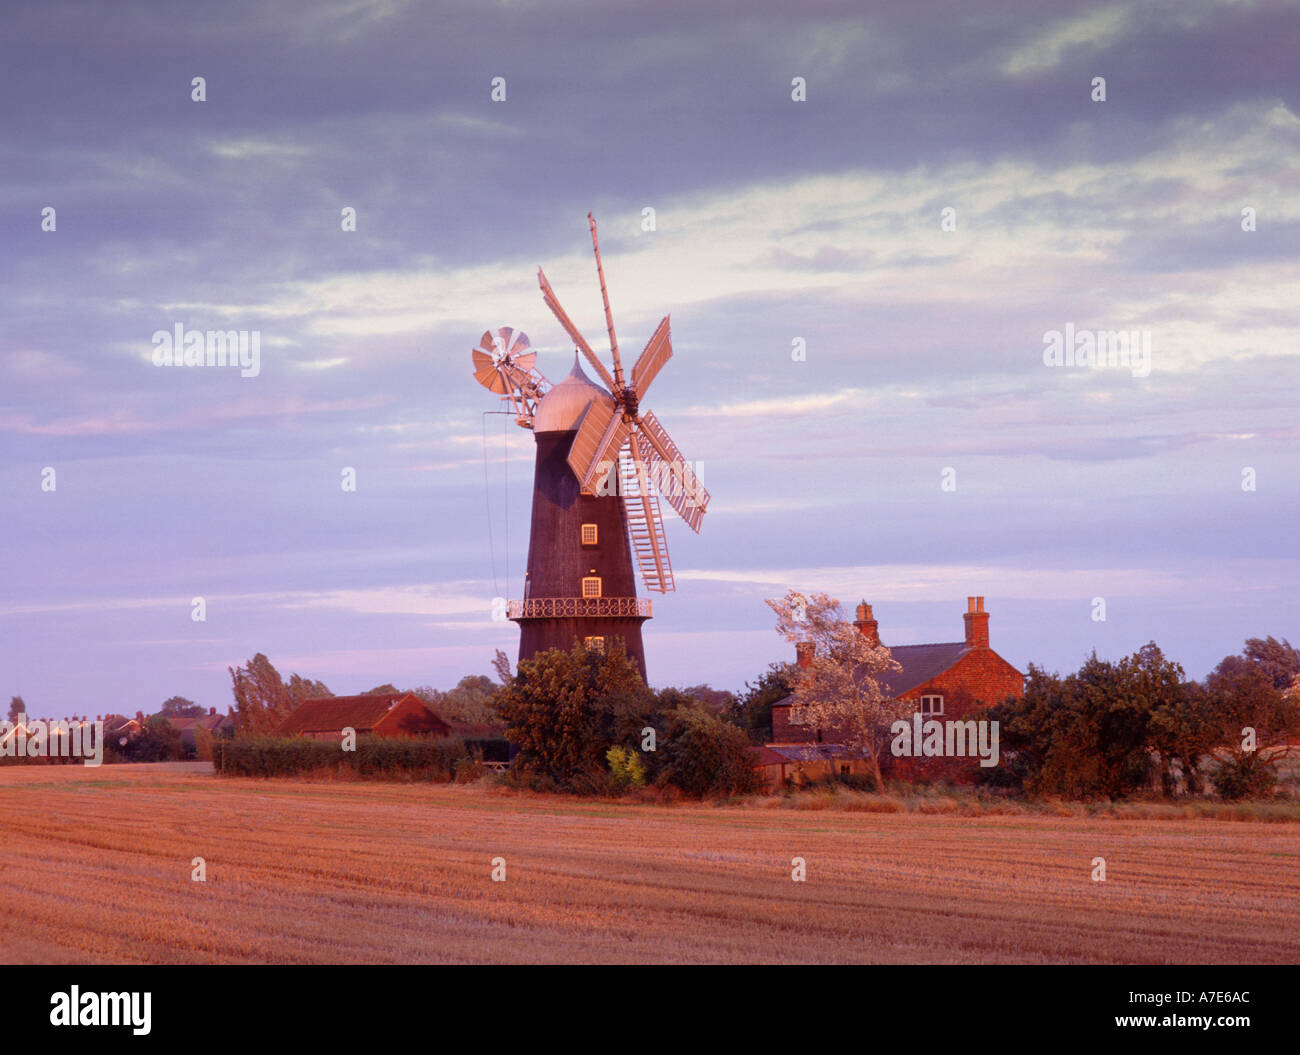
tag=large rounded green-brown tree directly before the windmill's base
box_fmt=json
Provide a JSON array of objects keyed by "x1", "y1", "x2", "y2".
[{"x1": 497, "y1": 642, "x2": 653, "y2": 791}]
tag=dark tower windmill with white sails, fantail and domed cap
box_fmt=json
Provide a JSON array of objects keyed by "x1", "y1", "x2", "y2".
[{"x1": 473, "y1": 213, "x2": 709, "y2": 677}]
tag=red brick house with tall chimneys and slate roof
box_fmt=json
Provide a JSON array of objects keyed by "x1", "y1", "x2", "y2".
[{"x1": 767, "y1": 596, "x2": 1024, "y2": 780}]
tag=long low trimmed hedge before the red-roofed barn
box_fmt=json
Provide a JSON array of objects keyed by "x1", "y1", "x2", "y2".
[{"x1": 212, "y1": 735, "x2": 477, "y2": 782}]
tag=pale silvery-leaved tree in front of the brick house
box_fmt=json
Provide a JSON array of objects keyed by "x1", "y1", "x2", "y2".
[{"x1": 767, "y1": 590, "x2": 913, "y2": 793}]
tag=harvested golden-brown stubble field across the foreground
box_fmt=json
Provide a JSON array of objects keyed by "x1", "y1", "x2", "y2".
[{"x1": 0, "y1": 765, "x2": 1300, "y2": 963}]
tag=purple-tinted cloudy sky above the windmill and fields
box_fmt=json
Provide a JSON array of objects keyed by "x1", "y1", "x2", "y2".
[{"x1": 0, "y1": 0, "x2": 1300, "y2": 717}]
